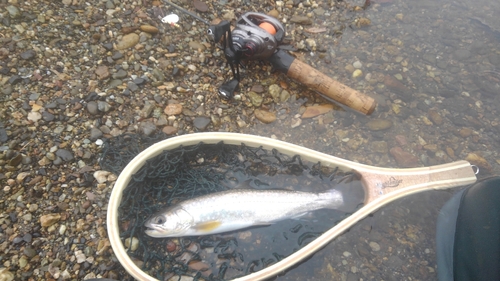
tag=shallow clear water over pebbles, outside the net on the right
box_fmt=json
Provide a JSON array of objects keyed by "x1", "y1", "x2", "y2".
[{"x1": 241, "y1": 0, "x2": 500, "y2": 280}]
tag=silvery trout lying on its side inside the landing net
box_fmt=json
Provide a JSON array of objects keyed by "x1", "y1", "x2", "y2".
[{"x1": 144, "y1": 189, "x2": 344, "y2": 238}]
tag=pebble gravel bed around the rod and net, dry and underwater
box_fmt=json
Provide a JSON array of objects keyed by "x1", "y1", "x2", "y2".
[{"x1": 0, "y1": 0, "x2": 500, "y2": 280}]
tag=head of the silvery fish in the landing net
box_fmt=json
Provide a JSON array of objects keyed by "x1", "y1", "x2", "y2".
[{"x1": 144, "y1": 207, "x2": 194, "y2": 238}]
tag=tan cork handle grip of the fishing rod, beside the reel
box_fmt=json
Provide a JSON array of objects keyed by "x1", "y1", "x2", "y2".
[{"x1": 269, "y1": 50, "x2": 377, "y2": 115}]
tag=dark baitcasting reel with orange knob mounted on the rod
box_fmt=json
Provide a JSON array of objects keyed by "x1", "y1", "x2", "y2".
[{"x1": 208, "y1": 12, "x2": 285, "y2": 99}]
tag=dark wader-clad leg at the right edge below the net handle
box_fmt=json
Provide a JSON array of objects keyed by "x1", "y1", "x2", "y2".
[{"x1": 436, "y1": 177, "x2": 500, "y2": 281}]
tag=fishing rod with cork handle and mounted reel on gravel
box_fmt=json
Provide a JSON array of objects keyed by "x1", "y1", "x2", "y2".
[{"x1": 165, "y1": 0, "x2": 376, "y2": 115}]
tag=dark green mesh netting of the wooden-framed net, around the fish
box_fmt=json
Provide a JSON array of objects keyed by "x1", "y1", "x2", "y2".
[{"x1": 99, "y1": 134, "x2": 362, "y2": 280}]
